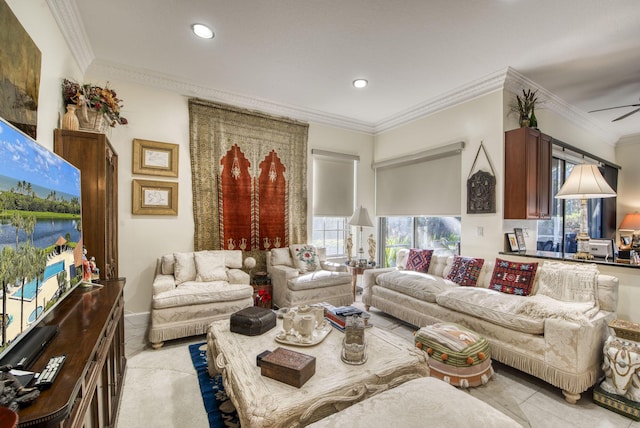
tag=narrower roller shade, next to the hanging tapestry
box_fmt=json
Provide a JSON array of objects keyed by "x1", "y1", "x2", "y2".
[{"x1": 312, "y1": 152, "x2": 358, "y2": 217}]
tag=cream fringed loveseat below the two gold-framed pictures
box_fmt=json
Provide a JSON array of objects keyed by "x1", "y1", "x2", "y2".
[{"x1": 149, "y1": 250, "x2": 253, "y2": 349}]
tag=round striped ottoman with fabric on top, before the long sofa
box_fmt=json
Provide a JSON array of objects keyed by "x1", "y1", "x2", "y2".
[{"x1": 415, "y1": 323, "x2": 493, "y2": 388}]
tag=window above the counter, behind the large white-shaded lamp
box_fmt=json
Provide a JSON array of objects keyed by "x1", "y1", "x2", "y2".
[{"x1": 537, "y1": 150, "x2": 617, "y2": 254}]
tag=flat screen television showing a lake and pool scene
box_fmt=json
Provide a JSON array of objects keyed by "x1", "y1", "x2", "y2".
[{"x1": 0, "y1": 118, "x2": 83, "y2": 369}]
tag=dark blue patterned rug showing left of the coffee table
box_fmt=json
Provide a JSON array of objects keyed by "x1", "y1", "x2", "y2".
[{"x1": 189, "y1": 343, "x2": 240, "y2": 428}]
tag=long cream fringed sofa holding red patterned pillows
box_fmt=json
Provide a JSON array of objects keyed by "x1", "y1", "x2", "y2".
[{"x1": 362, "y1": 250, "x2": 618, "y2": 403}]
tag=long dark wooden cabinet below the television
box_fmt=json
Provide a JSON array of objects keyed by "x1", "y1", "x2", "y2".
[{"x1": 18, "y1": 278, "x2": 127, "y2": 428}]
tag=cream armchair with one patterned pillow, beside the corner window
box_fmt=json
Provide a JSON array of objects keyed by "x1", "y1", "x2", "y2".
[{"x1": 267, "y1": 244, "x2": 353, "y2": 308}]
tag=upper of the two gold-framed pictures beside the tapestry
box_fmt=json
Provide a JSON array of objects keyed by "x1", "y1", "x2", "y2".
[{"x1": 132, "y1": 138, "x2": 179, "y2": 177}]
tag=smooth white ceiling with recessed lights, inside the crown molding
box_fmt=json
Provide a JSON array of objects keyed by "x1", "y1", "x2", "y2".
[{"x1": 48, "y1": 0, "x2": 640, "y2": 141}]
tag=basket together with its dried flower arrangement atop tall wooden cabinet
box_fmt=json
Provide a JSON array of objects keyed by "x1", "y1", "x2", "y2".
[{"x1": 62, "y1": 79, "x2": 129, "y2": 132}]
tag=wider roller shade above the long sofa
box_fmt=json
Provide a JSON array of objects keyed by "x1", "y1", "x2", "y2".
[{"x1": 376, "y1": 152, "x2": 462, "y2": 217}]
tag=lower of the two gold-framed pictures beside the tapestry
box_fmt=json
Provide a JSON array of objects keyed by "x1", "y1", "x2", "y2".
[{"x1": 132, "y1": 180, "x2": 178, "y2": 215}]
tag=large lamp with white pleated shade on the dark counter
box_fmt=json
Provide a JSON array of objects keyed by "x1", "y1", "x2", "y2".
[{"x1": 556, "y1": 164, "x2": 616, "y2": 260}]
